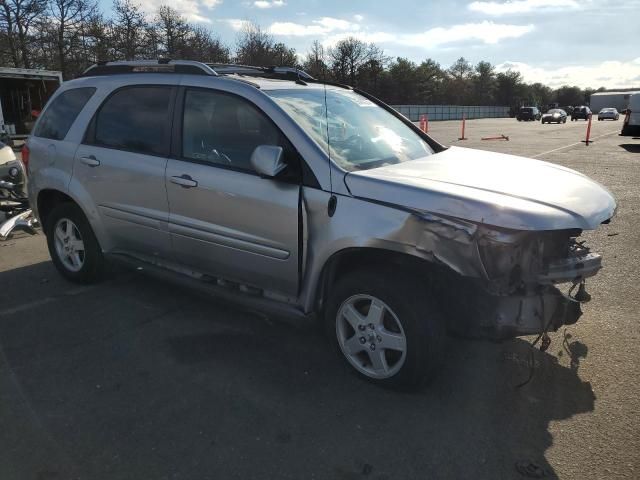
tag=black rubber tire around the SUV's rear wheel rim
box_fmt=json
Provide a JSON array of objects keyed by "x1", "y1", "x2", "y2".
[{"x1": 45, "y1": 203, "x2": 104, "y2": 284}]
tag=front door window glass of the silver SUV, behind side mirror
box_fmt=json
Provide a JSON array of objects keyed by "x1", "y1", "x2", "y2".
[{"x1": 182, "y1": 90, "x2": 288, "y2": 171}]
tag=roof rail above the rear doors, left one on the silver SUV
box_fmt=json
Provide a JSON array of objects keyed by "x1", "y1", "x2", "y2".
[{"x1": 80, "y1": 58, "x2": 218, "y2": 77}]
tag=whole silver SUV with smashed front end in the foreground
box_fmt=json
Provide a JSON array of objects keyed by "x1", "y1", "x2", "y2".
[{"x1": 24, "y1": 61, "x2": 616, "y2": 388}]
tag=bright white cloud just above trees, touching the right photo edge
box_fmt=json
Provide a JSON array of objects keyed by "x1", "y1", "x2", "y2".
[{"x1": 496, "y1": 57, "x2": 640, "y2": 88}]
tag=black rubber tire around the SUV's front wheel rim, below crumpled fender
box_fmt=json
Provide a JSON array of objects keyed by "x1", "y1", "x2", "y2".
[{"x1": 324, "y1": 269, "x2": 446, "y2": 390}]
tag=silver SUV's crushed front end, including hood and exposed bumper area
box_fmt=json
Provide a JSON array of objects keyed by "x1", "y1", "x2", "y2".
[{"x1": 347, "y1": 147, "x2": 617, "y2": 339}]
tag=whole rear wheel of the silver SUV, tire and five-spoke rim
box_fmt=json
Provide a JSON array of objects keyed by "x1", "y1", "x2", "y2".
[{"x1": 45, "y1": 203, "x2": 104, "y2": 283}]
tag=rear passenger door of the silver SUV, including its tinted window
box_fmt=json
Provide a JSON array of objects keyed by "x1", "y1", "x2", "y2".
[{"x1": 73, "y1": 85, "x2": 175, "y2": 257}]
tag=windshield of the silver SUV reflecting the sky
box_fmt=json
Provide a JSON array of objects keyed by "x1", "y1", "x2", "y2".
[{"x1": 266, "y1": 87, "x2": 433, "y2": 171}]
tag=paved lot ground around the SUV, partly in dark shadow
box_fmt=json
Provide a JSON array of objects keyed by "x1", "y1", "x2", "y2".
[{"x1": 0, "y1": 119, "x2": 640, "y2": 480}]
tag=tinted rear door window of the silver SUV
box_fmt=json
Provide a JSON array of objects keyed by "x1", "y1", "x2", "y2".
[{"x1": 93, "y1": 86, "x2": 172, "y2": 155}]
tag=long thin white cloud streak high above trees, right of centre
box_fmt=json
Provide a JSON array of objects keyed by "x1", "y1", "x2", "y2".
[{"x1": 323, "y1": 21, "x2": 534, "y2": 49}]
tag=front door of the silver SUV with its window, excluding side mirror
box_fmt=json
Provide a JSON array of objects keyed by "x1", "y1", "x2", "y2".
[{"x1": 166, "y1": 88, "x2": 300, "y2": 296}]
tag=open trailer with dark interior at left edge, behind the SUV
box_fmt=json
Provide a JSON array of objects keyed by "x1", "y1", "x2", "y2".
[{"x1": 0, "y1": 67, "x2": 62, "y2": 142}]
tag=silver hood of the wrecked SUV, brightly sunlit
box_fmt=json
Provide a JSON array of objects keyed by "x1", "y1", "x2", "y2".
[{"x1": 345, "y1": 147, "x2": 616, "y2": 230}]
